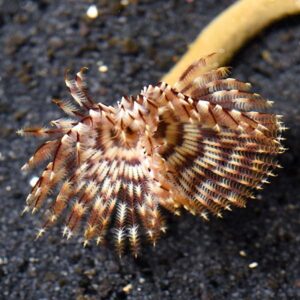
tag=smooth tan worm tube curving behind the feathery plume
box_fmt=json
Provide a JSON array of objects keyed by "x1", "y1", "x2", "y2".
[{"x1": 162, "y1": 0, "x2": 300, "y2": 84}]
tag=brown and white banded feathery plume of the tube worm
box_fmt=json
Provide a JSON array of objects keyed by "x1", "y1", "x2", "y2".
[{"x1": 19, "y1": 56, "x2": 284, "y2": 255}]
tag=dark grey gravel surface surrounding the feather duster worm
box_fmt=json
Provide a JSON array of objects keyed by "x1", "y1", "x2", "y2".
[{"x1": 0, "y1": 0, "x2": 300, "y2": 300}]
